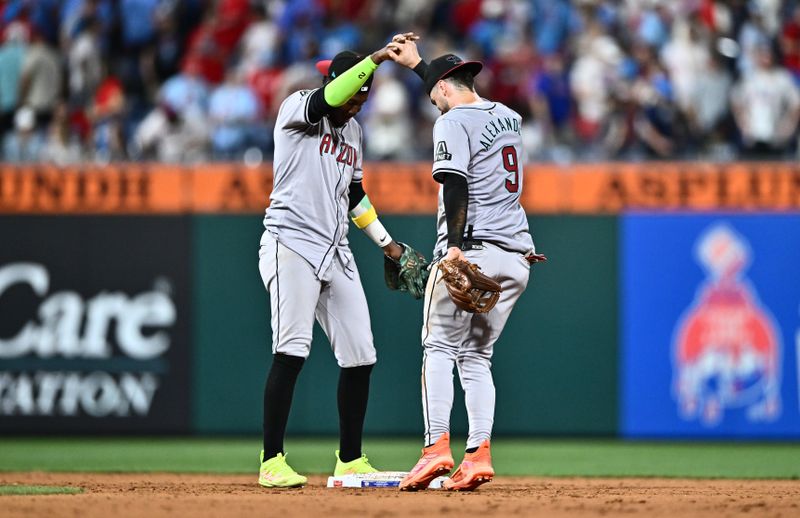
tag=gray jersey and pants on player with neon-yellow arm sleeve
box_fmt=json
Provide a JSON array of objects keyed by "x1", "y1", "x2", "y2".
[{"x1": 258, "y1": 90, "x2": 375, "y2": 367}]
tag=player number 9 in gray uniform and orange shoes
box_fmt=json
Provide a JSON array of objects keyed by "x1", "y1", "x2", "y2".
[{"x1": 396, "y1": 42, "x2": 543, "y2": 491}]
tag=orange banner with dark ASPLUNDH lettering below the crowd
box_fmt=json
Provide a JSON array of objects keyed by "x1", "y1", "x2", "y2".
[{"x1": 0, "y1": 162, "x2": 800, "y2": 214}]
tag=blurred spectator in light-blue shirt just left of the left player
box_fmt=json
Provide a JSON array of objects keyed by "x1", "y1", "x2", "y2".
[{"x1": 208, "y1": 68, "x2": 260, "y2": 159}]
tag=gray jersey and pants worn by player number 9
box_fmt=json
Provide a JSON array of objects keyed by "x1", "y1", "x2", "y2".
[{"x1": 422, "y1": 101, "x2": 534, "y2": 448}]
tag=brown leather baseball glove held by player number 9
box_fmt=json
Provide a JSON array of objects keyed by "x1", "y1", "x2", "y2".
[{"x1": 438, "y1": 259, "x2": 503, "y2": 313}]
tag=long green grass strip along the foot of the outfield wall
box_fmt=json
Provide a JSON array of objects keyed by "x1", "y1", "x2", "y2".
[{"x1": 0, "y1": 437, "x2": 800, "y2": 479}]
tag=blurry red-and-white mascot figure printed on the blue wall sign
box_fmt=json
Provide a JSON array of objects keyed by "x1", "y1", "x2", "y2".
[{"x1": 673, "y1": 223, "x2": 781, "y2": 426}]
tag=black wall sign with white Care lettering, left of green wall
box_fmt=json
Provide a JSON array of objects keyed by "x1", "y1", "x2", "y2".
[{"x1": 0, "y1": 217, "x2": 189, "y2": 433}]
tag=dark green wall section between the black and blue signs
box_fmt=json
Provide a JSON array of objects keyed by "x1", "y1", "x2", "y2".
[{"x1": 192, "y1": 215, "x2": 617, "y2": 435}]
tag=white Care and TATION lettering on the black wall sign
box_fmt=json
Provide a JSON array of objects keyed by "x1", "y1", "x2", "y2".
[{"x1": 0, "y1": 263, "x2": 176, "y2": 416}]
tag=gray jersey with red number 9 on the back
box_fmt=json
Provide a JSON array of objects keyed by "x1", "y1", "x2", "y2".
[{"x1": 433, "y1": 100, "x2": 533, "y2": 255}]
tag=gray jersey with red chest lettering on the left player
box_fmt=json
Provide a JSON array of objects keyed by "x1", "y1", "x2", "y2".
[{"x1": 264, "y1": 90, "x2": 362, "y2": 279}]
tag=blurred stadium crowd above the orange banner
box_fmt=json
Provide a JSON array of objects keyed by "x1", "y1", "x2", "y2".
[{"x1": 0, "y1": 0, "x2": 800, "y2": 164}]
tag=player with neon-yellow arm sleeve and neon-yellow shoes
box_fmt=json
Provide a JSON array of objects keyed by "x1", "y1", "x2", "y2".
[{"x1": 259, "y1": 33, "x2": 424, "y2": 487}]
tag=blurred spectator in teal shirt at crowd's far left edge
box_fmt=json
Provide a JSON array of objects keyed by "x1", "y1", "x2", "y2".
[{"x1": 0, "y1": 22, "x2": 28, "y2": 140}]
